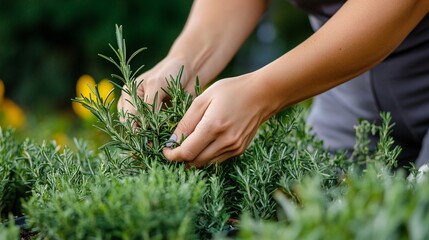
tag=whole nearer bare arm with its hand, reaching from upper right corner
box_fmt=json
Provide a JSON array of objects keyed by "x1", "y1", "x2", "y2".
[{"x1": 164, "y1": 0, "x2": 429, "y2": 167}]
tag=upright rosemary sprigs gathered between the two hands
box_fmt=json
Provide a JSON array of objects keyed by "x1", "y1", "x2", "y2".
[{"x1": 76, "y1": 26, "x2": 192, "y2": 169}]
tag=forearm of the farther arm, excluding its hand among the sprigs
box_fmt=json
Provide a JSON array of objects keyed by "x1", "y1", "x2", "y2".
[{"x1": 166, "y1": 0, "x2": 267, "y2": 85}]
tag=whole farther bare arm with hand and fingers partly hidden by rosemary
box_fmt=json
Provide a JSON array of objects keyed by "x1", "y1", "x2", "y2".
[{"x1": 118, "y1": 0, "x2": 267, "y2": 114}]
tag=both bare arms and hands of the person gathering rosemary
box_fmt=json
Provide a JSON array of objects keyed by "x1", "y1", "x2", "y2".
[{"x1": 118, "y1": 0, "x2": 429, "y2": 167}]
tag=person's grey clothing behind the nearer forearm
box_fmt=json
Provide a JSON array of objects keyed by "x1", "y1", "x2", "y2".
[{"x1": 290, "y1": 0, "x2": 429, "y2": 166}]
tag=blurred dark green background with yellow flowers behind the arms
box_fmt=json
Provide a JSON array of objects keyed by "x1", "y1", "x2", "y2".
[{"x1": 0, "y1": 0, "x2": 311, "y2": 147}]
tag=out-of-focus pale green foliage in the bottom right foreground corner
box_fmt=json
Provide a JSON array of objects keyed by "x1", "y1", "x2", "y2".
[{"x1": 239, "y1": 163, "x2": 429, "y2": 239}]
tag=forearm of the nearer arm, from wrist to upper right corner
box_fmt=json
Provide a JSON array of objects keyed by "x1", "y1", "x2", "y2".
[{"x1": 252, "y1": 0, "x2": 428, "y2": 114}]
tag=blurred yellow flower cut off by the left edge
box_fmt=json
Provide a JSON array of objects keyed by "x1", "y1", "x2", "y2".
[{"x1": 0, "y1": 98, "x2": 25, "y2": 128}]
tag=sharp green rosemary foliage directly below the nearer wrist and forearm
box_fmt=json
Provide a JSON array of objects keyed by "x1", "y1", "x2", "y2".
[{"x1": 227, "y1": 109, "x2": 346, "y2": 219}]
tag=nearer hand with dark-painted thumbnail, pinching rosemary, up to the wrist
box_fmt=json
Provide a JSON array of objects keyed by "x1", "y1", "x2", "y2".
[{"x1": 163, "y1": 74, "x2": 274, "y2": 167}]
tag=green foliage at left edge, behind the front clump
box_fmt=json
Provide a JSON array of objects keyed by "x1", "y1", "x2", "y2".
[{"x1": 0, "y1": 125, "x2": 138, "y2": 218}]
